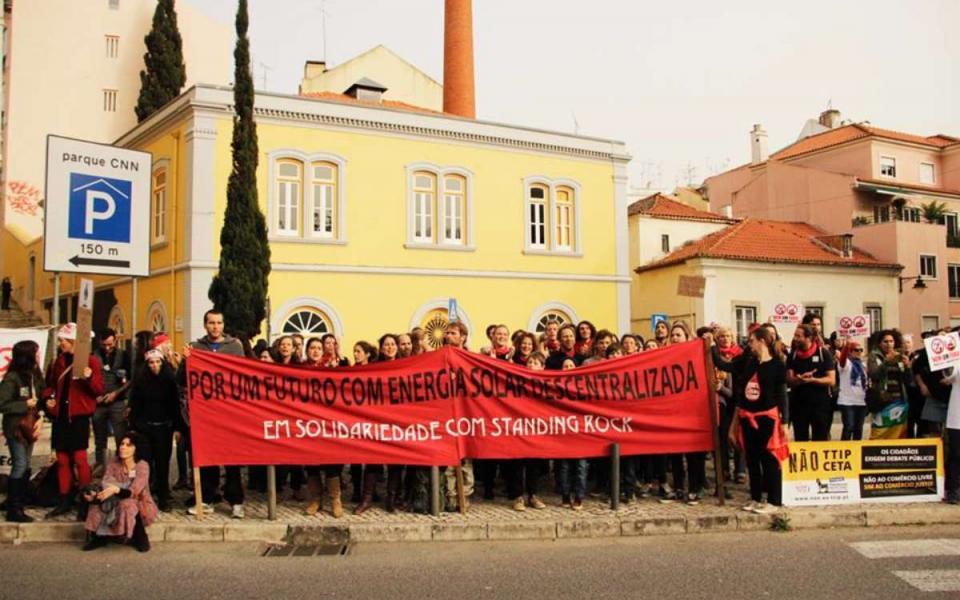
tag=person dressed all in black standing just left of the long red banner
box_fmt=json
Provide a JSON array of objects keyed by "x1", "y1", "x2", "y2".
[{"x1": 130, "y1": 349, "x2": 180, "y2": 511}]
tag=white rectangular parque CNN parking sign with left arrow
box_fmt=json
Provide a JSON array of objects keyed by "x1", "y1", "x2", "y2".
[{"x1": 43, "y1": 135, "x2": 152, "y2": 276}]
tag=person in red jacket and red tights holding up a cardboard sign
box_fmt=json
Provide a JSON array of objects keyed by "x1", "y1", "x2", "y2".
[{"x1": 43, "y1": 323, "x2": 103, "y2": 521}]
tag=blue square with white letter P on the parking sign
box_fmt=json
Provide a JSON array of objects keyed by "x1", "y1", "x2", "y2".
[{"x1": 67, "y1": 173, "x2": 132, "y2": 242}]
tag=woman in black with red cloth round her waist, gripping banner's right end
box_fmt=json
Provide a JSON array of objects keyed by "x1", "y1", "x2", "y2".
[{"x1": 712, "y1": 327, "x2": 790, "y2": 514}]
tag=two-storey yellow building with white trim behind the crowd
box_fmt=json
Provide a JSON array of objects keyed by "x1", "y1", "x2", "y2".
[{"x1": 14, "y1": 85, "x2": 630, "y2": 348}]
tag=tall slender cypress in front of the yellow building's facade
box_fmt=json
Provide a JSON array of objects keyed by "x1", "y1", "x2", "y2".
[{"x1": 209, "y1": 0, "x2": 270, "y2": 340}]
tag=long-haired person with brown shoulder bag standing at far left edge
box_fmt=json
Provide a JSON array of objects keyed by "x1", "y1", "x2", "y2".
[{"x1": 0, "y1": 340, "x2": 43, "y2": 523}]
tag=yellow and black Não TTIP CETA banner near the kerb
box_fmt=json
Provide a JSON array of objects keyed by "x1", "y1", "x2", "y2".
[{"x1": 782, "y1": 439, "x2": 943, "y2": 506}]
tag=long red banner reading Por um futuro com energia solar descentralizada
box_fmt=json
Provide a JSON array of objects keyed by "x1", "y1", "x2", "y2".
[{"x1": 187, "y1": 341, "x2": 713, "y2": 466}]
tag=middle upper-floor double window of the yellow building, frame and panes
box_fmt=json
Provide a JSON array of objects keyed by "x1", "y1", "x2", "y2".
[{"x1": 407, "y1": 163, "x2": 473, "y2": 248}]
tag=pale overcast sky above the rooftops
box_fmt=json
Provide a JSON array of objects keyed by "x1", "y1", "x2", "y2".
[{"x1": 188, "y1": 0, "x2": 960, "y2": 189}]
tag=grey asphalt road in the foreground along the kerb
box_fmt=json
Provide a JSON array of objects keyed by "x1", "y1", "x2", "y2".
[{"x1": 0, "y1": 526, "x2": 960, "y2": 600}]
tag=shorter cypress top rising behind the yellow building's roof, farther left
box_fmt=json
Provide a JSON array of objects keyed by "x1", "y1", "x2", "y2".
[{"x1": 134, "y1": 0, "x2": 187, "y2": 122}]
